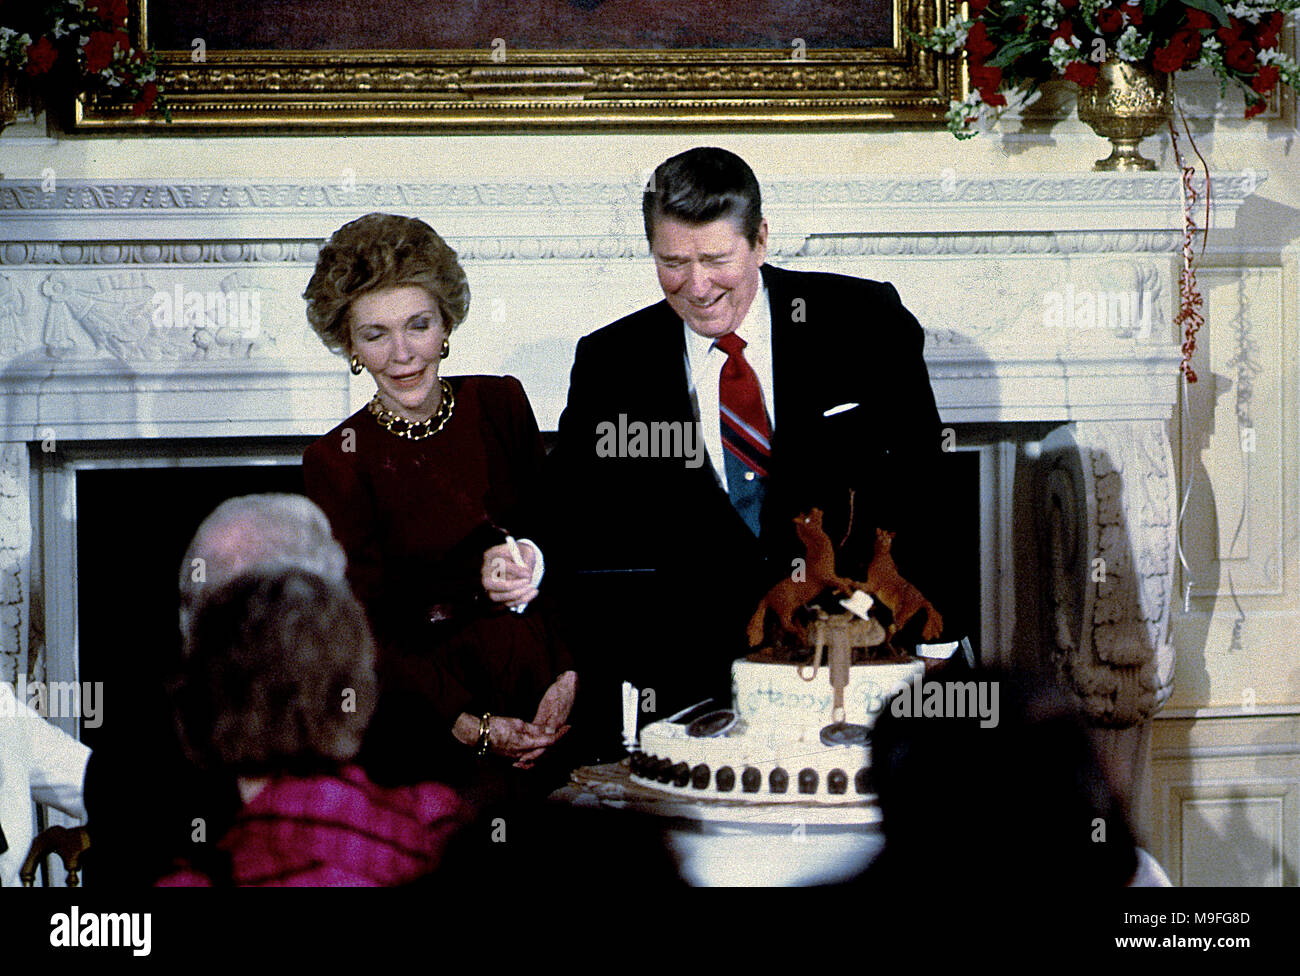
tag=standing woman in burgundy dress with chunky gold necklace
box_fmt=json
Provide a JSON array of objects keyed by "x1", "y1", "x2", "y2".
[{"x1": 303, "y1": 213, "x2": 577, "y2": 780}]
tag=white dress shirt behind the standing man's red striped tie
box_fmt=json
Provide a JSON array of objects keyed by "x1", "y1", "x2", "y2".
[{"x1": 681, "y1": 285, "x2": 776, "y2": 493}]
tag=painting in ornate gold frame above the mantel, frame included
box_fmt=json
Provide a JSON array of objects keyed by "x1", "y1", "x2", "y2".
[{"x1": 74, "y1": 0, "x2": 961, "y2": 131}]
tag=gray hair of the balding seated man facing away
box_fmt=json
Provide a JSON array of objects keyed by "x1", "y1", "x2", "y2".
[{"x1": 181, "y1": 494, "x2": 347, "y2": 641}]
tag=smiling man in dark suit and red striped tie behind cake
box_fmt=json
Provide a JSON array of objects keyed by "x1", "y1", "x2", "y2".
[{"x1": 550, "y1": 148, "x2": 946, "y2": 725}]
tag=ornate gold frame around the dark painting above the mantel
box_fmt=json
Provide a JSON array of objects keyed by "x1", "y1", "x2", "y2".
[{"x1": 73, "y1": 0, "x2": 961, "y2": 133}]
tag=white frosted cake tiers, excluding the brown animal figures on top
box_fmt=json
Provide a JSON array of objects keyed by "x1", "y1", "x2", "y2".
[{"x1": 632, "y1": 654, "x2": 924, "y2": 803}]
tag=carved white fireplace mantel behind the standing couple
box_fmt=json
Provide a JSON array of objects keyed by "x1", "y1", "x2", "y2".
[{"x1": 0, "y1": 173, "x2": 1260, "y2": 715}]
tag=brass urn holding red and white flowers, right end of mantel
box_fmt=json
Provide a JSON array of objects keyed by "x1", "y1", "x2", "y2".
[{"x1": 1079, "y1": 55, "x2": 1173, "y2": 170}]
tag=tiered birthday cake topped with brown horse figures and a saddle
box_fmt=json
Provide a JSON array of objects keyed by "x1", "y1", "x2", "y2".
[{"x1": 631, "y1": 509, "x2": 943, "y2": 803}]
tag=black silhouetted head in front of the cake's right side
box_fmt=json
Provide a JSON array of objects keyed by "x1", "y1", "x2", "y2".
[{"x1": 866, "y1": 669, "x2": 1138, "y2": 890}]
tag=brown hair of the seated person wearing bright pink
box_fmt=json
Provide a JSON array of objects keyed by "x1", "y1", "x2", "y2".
[{"x1": 174, "y1": 569, "x2": 377, "y2": 776}]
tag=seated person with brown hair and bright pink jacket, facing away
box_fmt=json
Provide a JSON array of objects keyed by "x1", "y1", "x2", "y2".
[{"x1": 159, "y1": 569, "x2": 464, "y2": 886}]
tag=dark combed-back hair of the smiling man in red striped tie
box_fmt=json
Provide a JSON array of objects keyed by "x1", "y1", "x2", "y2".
[{"x1": 641, "y1": 147, "x2": 763, "y2": 247}]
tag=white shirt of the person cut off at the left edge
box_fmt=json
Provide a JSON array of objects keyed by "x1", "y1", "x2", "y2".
[{"x1": 0, "y1": 681, "x2": 90, "y2": 888}]
